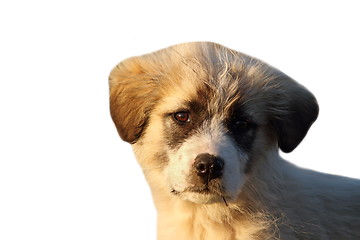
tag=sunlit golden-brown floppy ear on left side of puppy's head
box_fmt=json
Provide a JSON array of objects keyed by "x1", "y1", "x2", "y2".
[{"x1": 109, "y1": 57, "x2": 157, "y2": 144}]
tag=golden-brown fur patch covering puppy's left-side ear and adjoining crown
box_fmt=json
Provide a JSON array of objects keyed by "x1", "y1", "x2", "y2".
[{"x1": 109, "y1": 44, "x2": 207, "y2": 143}]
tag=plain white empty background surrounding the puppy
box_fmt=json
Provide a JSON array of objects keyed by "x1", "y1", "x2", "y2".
[{"x1": 0, "y1": 0, "x2": 360, "y2": 240}]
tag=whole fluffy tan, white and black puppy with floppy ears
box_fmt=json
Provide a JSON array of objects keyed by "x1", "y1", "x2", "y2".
[{"x1": 110, "y1": 42, "x2": 360, "y2": 240}]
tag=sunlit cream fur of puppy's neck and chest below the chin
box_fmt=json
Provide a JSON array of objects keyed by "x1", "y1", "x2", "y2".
[{"x1": 155, "y1": 190, "x2": 269, "y2": 240}]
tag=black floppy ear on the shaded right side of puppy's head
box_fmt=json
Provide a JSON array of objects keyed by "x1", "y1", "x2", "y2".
[{"x1": 271, "y1": 75, "x2": 319, "y2": 153}]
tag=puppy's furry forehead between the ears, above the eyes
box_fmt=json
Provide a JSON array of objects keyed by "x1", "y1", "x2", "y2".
[{"x1": 153, "y1": 43, "x2": 276, "y2": 119}]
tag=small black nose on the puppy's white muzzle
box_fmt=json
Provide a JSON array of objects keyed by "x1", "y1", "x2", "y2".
[{"x1": 194, "y1": 153, "x2": 224, "y2": 181}]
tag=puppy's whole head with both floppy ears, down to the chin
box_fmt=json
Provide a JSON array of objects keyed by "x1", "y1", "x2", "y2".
[{"x1": 110, "y1": 43, "x2": 318, "y2": 204}]
